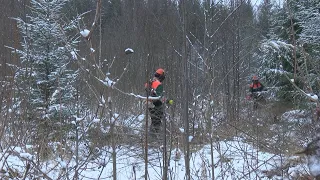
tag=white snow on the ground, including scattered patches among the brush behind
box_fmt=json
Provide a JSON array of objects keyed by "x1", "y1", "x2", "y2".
[{"x1": 0, "y1": 110, "x2": 318, "y2": 180}]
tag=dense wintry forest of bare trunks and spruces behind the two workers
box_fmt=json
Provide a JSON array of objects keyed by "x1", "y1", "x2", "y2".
[{"x1": 0, "y1": 0, "x2": 320, "y2": 178}]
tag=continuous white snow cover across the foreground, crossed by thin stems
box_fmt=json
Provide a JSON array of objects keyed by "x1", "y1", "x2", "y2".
[{"x1": 1, "y1": 138, "x2": 308, "y2": 180}]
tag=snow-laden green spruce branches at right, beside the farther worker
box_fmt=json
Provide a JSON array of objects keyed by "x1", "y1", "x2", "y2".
[{"x1": 255, "y1": 1, "x2": 319, "y2": 108}]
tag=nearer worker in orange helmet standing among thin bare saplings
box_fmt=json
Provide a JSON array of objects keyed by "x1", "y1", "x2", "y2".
[{"x1": 145, "y1": 68, "x2": 165, "y2": 133}]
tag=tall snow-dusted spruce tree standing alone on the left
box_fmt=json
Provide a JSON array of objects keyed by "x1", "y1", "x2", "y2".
[{"x1": 15, "y1": 0, "x2": 78, "y2": 151}]
